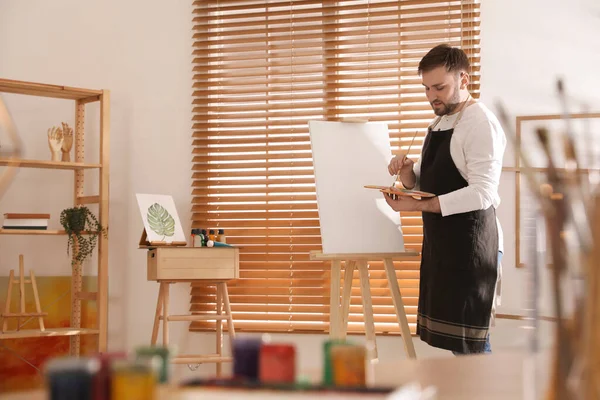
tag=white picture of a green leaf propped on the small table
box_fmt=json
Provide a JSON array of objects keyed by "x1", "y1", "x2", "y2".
[{"x1": 136, "y1": 193, "x2": 186, "y2": 244}]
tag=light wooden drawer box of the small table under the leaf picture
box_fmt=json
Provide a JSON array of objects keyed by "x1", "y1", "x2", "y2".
[{"x1": 147, "y1": 247, "x2": 239, "y2": 281}]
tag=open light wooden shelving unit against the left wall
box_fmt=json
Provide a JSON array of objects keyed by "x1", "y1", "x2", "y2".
[{"x1": 0, "y1": 79, "x2": 110, "y2": 355}]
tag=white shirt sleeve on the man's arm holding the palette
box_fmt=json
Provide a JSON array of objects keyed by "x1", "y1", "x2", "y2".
[{"x1": 439, "y1": 121, "x2": 506, "y2": 216}]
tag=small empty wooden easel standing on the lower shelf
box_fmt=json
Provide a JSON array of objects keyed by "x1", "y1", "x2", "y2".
[{"x1": 0, "y1": 254, "x2": 48, "y2": 333}]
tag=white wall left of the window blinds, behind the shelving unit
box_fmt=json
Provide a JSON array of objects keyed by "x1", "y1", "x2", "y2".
[{"x1": 0, "y1": 0, "x2": 192, "y2": 356}]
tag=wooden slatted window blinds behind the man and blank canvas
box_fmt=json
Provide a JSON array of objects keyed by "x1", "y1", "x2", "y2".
[{"x1": 190, "y1": 0, "x2": 480, "y2": 334}]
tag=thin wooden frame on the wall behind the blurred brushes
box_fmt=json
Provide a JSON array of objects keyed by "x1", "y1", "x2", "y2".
[{"x1": 510, "y1": 113, "x2": 600, "y2": 268}]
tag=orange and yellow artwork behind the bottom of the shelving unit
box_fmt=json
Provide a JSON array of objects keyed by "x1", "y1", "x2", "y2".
[{"x1": 0, "y1": 271, "x2": 98, "y2": 393}]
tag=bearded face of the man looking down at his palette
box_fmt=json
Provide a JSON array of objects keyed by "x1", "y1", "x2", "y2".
[{"x1": 421, "y1": 66, "x2": 463, "y2": 115}]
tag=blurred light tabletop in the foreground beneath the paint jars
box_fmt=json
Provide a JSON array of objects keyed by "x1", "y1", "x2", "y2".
[{"x1": 0, "y1": 353, "x2": 550, "y2": 400}]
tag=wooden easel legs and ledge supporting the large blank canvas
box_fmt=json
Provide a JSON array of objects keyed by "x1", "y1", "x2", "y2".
[{"x1": 310, "y1": 251, "x2": 419, "y2": 358}]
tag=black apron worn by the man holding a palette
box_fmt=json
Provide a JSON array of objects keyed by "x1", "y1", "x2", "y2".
[{"x1": 417, "y1": 107, "x2": 499, "y2": 353}]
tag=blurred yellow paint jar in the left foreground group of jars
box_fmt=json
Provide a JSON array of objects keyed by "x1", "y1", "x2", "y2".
[{"x1": 111, "y1": 357, "x2": 161, "y2": 400}]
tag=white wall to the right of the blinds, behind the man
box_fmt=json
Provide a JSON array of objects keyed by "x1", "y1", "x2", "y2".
[{"x1": 481, "y1": 0, "x2": 600, "y2": 315}]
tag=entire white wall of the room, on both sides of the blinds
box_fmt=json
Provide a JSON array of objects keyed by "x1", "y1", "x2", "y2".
[{"x1": 0, "y1": 0, "x2": 600, "y2": 382}]
